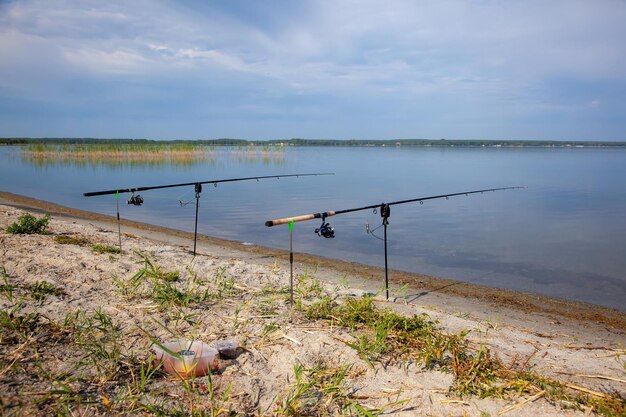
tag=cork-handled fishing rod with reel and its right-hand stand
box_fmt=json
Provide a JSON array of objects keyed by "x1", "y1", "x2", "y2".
[{"x1": 265, "y1": 187, "x2": 526, "y2": 299}]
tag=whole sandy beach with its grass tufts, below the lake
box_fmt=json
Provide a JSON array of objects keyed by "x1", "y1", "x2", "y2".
[{"x1": 0, "y1": 193, "x2": 626, "y2": 416}]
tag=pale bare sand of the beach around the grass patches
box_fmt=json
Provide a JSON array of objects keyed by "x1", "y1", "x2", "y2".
[{"x1": 0, "y1": 193, "x2": 626, "y2": 416}]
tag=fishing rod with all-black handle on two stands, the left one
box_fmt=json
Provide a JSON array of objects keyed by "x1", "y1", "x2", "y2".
[{"x1": 83, "y1": 172, "x2": 335, "y2": 256}]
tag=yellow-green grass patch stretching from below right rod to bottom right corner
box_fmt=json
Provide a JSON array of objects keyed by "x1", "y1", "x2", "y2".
[{"x1": 301, "y1": 290, "x2": 624, "y2": 416}]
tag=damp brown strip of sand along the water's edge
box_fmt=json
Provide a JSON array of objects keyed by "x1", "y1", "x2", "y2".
[{"x1": 0, "y1": 191, "x2": 626, "y2": 331}]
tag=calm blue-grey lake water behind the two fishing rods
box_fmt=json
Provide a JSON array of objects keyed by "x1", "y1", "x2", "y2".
[{"x1": 0, "y1": 147, "x2": 626, "y2": 311}]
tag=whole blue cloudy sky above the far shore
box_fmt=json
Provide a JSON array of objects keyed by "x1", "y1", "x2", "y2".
[{"x1": 0, "y1": 0, "x2": 626, "y2": 141}]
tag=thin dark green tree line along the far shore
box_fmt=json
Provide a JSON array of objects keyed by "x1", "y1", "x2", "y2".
[{"x1": 0, "y1": 138, "x2": 626, "y2": 148}]
